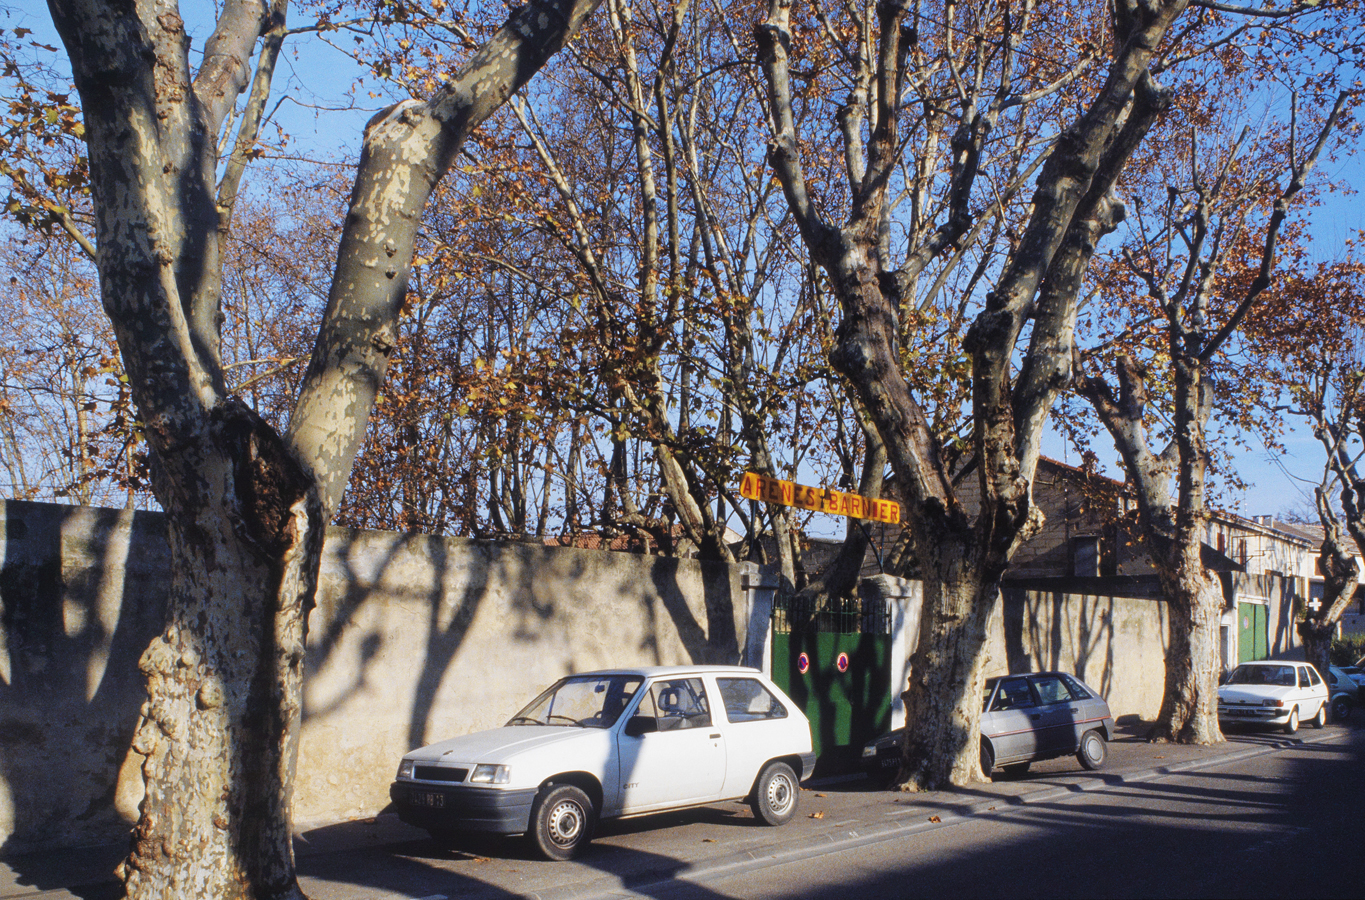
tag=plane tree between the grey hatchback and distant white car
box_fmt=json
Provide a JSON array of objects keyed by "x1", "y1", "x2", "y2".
[{"x1": 1074, "y1": 94, "x2": 1347, "y2": 744}]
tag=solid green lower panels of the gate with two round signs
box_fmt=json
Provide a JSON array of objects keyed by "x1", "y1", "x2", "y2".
[{"x1": 773, "y1": 632, "x2": 891, "y2": 774}]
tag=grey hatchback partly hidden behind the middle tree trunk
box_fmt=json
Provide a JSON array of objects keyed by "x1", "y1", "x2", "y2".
[{"x1": 863, "y1": 672, "x2": 1114, "y2": 781}]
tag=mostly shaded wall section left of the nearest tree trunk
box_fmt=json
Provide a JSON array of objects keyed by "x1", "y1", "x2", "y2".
[{"x1": 0, "y1": 501, "x2": 169, "y2": 896}]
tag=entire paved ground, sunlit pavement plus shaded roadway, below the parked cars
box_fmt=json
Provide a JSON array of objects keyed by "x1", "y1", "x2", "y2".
[{"x1": 0, "y1": 722, "x2": 1365, "y2": 900}]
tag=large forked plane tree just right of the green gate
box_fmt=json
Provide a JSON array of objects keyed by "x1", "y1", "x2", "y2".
[{"x1": 755, "y1": 0, "x2": 1354, "y2": 788}]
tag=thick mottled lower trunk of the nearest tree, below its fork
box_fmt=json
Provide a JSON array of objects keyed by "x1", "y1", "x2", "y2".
[{"x1": 114, "y1": 402, "x2": 325, "y2": 897}]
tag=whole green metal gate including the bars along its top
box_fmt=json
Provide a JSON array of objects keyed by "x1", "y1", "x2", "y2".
[{"x1": 773, "y1": 598, "x2": 891, "y2": 774}]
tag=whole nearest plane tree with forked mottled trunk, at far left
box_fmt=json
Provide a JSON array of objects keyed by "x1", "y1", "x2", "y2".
[{"x1": 37, "y1": 0, "x2": 608, "y2": 897}]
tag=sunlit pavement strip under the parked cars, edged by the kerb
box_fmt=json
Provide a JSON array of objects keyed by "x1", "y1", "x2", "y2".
[{"x1": 0, "y1": 724, "x2": 1351, "y2": 900}]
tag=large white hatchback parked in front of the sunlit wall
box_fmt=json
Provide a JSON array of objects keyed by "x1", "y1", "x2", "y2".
[{"x1": 389, "y1": 666, "x2": 815, "y2": 859}]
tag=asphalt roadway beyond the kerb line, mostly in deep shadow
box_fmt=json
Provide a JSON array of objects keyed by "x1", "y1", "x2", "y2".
[{"x1": 625, "y1": 732, "x2": 1365, "y2": 900}]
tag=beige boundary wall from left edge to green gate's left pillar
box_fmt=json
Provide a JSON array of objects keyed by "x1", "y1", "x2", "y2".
[{"x1": 0, "y1": 501, "x2": 773, "y2": 852}]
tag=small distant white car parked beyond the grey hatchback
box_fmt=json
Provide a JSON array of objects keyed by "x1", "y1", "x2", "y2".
[{"x1": 1218, "y1": 660, "x2": 1328, "y2": 735}]
